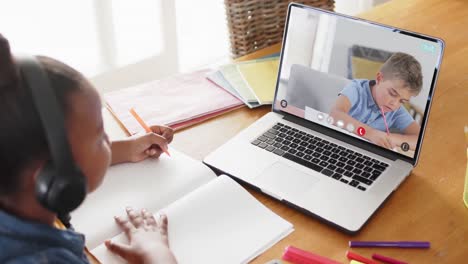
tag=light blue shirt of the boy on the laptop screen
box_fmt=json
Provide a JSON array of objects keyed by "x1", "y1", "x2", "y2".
[{"x1": 340, "y1": 79, "x2": 414, "y2": 133}]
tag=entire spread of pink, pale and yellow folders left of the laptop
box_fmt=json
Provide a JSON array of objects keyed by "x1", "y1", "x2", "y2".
[{"x1": 104, "y1": 56, "x2": 279, "y2": 134}]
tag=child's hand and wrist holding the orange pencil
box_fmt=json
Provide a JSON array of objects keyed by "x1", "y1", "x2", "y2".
[{"x1": 112, "y1": 126, "x2": 174, "y2": 164}]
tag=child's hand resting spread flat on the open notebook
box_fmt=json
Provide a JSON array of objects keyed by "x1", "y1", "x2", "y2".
[{"x1": 105, "y1": 207, "x2": 177, "y2": 263}]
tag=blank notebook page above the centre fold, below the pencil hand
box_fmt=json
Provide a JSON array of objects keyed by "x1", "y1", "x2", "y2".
[{"x1": 71, "y1": 148, "x2": 216, "y2": 249}]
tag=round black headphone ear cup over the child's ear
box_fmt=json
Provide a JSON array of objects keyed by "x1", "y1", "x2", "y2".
[{"x1": 36, "y1": 163, "x2": 87, "y2": 214}]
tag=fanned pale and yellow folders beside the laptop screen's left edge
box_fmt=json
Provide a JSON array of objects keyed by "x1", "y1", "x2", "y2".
[{"x1": 207, "y1": 57, "x2": 279, "y2": 108}]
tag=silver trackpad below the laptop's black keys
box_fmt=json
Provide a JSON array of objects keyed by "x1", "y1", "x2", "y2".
[{"x1": 256, "y1": 162, "x2": 319, "y2": 197}]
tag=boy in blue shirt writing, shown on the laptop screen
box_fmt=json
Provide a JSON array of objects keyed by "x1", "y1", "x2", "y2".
[{"x1": 330, "y1": 52, "x2": 422, "y2": 150}]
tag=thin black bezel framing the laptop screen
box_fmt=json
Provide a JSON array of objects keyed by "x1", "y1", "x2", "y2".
[{"x1": 272, "y1": 3, "x2": 445, "y2": 166}]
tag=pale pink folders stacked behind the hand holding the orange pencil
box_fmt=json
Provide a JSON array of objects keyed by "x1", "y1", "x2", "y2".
[{"x1": 104, "y1": 70, "x2": 243, "y2": 135}]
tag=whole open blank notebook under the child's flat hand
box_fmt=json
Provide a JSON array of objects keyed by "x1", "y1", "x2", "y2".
[{"x1": 72, "y1": 149, "x2": 293, "y2": 263}]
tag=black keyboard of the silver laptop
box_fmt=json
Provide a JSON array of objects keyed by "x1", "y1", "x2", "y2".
[{"x1": 251, "y1": 123, "x2": 388, "y2": 191}]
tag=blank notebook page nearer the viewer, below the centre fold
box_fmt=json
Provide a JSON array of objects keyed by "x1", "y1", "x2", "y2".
[{"x1": 93, "y1": 175, "x2": 293, "y2": 264}]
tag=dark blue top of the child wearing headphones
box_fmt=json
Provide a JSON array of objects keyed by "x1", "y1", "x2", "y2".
[{"x1": 0, "y1": 209, "x2": 89, "y2": 264}]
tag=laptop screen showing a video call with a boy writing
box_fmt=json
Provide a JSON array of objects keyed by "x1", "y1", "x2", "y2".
[{"x1": 273, "y1": 4, "x2": 443, "y2": 159}]
